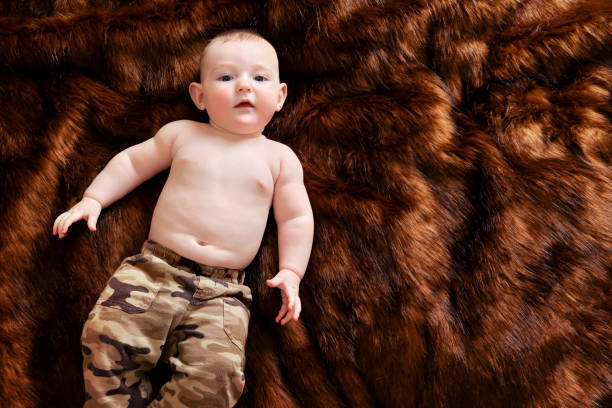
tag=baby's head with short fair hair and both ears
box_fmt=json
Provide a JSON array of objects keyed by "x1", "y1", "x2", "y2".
[{"x1": 189, "y1": 30, "x2": 287, "y2": 136}]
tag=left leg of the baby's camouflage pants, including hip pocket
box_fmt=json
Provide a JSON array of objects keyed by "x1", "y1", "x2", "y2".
[{"x1": 81, "y1": 255, "x2": 172, "y2": 408}]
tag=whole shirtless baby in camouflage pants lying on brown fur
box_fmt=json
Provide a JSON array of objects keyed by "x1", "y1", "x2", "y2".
[{"x1": 53, "y1": 30, "x2": 313, "y2": 408}]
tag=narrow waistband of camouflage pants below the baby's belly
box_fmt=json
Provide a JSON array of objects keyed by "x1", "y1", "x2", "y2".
[{"x1": 141, "y1": 239, "x2": 244, "y2": 285}]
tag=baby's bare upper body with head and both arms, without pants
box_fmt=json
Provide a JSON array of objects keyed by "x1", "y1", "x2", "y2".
[{"x1": 53, "y1": 39, "x2": 313, "y2": 324}]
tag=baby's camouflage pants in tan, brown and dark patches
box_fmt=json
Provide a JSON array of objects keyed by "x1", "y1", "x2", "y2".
[{"x1": 81, "y1": 241, "x2": 251, "y2": 408}]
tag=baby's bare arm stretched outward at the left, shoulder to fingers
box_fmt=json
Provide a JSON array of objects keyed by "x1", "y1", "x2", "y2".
[{"x1": 53, "y1": 122, "x2": 177, "y2": 238}]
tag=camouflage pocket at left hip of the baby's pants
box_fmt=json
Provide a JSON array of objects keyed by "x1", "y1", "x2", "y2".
[{"x1": 96, "y1": 255, "x2": 162, "y2": 314}]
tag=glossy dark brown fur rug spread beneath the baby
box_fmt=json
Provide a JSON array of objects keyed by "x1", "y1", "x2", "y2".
[{"x1": 0, "y1": 0, "x2": 612, "y2": 408}]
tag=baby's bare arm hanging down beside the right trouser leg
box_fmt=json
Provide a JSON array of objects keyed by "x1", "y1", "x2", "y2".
[{"x1": 266, "y1": 146, "x2": 314, "y2": 325}]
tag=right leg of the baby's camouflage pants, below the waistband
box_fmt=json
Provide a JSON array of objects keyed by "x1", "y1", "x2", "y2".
[{"x1": 150, "y1": 276, "x2": 251, "y2": 408}]
